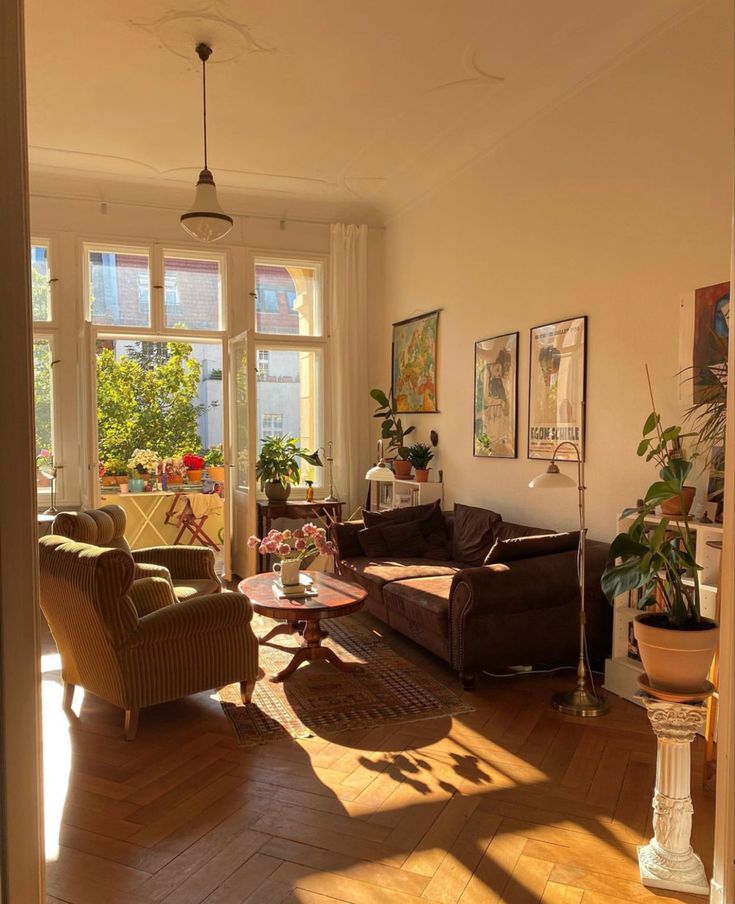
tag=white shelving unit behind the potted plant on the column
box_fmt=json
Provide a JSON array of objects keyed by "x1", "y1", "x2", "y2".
[{"x1": 604, "y1": 515, "x2": 722, "y2": 706}]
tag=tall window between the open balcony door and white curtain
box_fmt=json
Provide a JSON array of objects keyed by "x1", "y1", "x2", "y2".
[{"x1": 255, "y1": 259, "x2": 326, "y2": 486}]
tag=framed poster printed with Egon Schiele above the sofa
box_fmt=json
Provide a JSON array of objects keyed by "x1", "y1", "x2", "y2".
[{"x1": 528, "y1": 317, "x2": 587, "y2": 461}]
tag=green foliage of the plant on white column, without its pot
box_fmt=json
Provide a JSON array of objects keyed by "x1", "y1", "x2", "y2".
[{"x1": 602, "y1": 382, "x2": 701, "y2": 628}]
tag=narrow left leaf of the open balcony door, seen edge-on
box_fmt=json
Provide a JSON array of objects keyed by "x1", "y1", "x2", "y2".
[{"x1": 77, "y1": 321, "x2": 100, "y2": 509}]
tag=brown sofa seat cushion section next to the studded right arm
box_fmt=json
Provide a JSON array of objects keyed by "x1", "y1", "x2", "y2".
[{"x1": 383, "y1": 575, "x2": 452, "y2": 660}]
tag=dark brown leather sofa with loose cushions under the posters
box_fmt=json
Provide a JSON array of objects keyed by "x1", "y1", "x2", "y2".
[{"x1": 334, "y1": 506, "x2": 612, "y2": 690}]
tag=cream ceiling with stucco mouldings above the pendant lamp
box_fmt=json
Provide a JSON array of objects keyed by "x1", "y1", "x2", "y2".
[{"x1": 26, "y1": 0, "x2": 702, "y2": 222}]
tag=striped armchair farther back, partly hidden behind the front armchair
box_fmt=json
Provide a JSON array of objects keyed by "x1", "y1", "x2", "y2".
[{"x1": 51, "y1": 505, "x2": 222, "y2": 600}]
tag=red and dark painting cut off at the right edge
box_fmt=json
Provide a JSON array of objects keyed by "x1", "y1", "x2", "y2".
[{"x1": 692, "y1": 282, "x2": 730, "y2": 405}]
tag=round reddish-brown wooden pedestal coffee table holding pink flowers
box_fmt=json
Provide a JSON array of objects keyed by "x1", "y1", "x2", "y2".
[{"x1": 237, "y1": 571, "x2": 367, "y2": 681}]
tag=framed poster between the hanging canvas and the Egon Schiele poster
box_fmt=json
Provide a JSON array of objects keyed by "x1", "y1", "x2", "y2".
[{"x1": 472, "y1": 333, "x2": 518, "y2": 458}]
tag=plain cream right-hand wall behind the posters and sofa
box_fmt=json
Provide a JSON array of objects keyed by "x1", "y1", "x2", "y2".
[{"x1": 371, "y1": 0, "x2": 733, "y2": 538}]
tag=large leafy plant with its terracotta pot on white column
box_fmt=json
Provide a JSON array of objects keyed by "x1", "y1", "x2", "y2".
[{"x1": 602, "y1": 407, "x2": 719, "y2": 696}]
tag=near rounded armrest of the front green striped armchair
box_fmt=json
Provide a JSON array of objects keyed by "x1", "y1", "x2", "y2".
[{"x1": 125, "y1": 593, "x2": 253, "y2": 648}]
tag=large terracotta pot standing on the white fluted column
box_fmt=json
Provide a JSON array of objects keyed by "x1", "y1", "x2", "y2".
[{"x1": 633, "y1": 612, "x2": 720, "y2": 695}]
